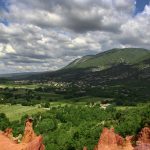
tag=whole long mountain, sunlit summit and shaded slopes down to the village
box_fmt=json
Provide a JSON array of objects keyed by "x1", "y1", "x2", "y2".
[{"x1": 0, "y1": 48, "x2": 150, "y2": 83}]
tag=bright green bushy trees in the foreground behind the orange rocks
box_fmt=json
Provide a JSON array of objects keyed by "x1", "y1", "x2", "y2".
[{"x1": 0, "y1": 105, "x2": 150, "y2": 150}]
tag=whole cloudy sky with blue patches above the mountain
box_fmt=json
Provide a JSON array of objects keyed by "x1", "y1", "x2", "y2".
[{"x1": 0, "y1": 0, "x2": 150, "y2": 74}]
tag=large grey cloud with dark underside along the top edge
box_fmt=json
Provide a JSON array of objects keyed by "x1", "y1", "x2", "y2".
[{"x1": 9, "y1": 0, "x2": 133, "y2": 32}]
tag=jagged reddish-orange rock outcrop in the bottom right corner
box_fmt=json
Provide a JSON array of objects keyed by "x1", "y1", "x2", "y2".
[{"x1": 84, "y1": 127, "x2": 150, "y2": 150}]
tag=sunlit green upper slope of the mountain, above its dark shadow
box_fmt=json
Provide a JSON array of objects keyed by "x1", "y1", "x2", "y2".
[{"x1": 65, "y1": 48, "x2": 150, "y2": 70}]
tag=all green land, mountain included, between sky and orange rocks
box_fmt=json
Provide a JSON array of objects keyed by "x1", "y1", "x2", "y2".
[{"x1": 0, "y1": 48, "x2": 150, "y2": 150}]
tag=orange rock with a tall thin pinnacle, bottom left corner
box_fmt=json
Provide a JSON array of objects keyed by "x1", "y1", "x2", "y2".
[{"x1": 0, "y1": 119, "x2": 45, "y2": 150}]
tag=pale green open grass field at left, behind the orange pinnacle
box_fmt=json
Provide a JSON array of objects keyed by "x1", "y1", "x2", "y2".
[{"x1": 0, "y1": 104, "x2": 45, "y2": 121}]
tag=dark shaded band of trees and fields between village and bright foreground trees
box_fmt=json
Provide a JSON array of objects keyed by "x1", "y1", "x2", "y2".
[{"x1": 0, "y1": 80, "x2": 150, "y2": 108}]
